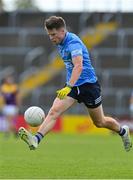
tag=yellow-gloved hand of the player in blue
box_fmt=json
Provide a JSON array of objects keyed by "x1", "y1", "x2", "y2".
[{"x1": 56, "y1": 86, "x2": 72, "y2": 99}]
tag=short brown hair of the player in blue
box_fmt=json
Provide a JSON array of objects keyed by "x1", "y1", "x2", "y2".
[{"x1": 44, "y1": 16, "x2": 66, "y2": 30}]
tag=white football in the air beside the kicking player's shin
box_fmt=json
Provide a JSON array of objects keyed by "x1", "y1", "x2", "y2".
[{"x1": 24, "y1": 106, "x2": 45, "y2": 127}]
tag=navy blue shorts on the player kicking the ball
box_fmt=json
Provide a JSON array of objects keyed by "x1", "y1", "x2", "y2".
[{"x1": 68, "y1": 81, "x2": 102, "y2": 108}]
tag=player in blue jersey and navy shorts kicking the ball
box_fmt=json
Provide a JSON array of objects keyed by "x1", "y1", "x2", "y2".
[{"x1": 19, "y1": 16, "x2": 132, "y2": 151}]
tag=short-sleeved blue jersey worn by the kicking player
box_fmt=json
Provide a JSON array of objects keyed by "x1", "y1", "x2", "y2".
[{"x1": 58, "y1": 32, "x2": 97, "y2": 86}]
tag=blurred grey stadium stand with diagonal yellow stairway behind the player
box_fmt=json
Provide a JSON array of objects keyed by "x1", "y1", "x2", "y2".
[{"x1": 0, "y1": 0, "x2": 133, "y2": 132}]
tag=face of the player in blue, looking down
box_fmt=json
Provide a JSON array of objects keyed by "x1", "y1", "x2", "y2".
[{"x1": 46, "y1": 28, "x2": 66, "y2": 45}]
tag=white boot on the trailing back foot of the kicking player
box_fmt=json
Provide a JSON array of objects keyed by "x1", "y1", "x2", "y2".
[{"x1": 121, "y1": 125, "x2": 132, "y2": 152}]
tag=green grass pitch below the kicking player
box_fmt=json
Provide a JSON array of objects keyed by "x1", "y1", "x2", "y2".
[{"x1": 0, "y1": 134, "x2": 133, "y2": 179}]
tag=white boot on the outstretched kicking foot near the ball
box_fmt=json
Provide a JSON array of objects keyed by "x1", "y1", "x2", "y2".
[{"x1": 18, "y1": 127, "x2": 38, "y2": 150}]
